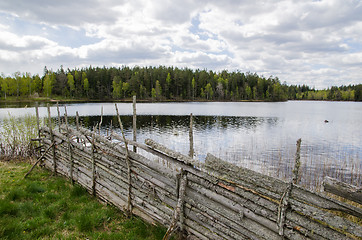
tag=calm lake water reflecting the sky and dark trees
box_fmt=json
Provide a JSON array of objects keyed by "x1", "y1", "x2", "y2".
[{"x1": 0, "y1": 101, "x2": 362, "y2": 186}]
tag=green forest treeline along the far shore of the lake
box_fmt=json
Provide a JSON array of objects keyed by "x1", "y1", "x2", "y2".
[{"x1": 0, "y1": 66, "x2": 362, "y2": 101}]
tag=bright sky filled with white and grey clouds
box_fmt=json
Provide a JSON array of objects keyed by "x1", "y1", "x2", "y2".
[{"x1": 0, "y1": 0, "x2": 362, "y2": 89}]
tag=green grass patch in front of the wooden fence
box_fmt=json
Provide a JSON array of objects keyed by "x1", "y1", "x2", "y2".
[{"x1": 0, "y1": 161, "x2": 166, "y2": 240}]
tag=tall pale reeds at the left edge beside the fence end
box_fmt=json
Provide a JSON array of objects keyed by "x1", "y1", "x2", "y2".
[{"x1": 0, "y1": 113, "x2": 38, "y2": 159}]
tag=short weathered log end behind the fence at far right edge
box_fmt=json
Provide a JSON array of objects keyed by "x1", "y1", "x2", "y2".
[{"x1": 322, "y1": 176, "x2": 362, "y2": 204}]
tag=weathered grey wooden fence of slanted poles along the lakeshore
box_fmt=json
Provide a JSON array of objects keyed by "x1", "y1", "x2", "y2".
[{"x1": 40, "y1": 105, "x2": 362, "y2": 240}]
